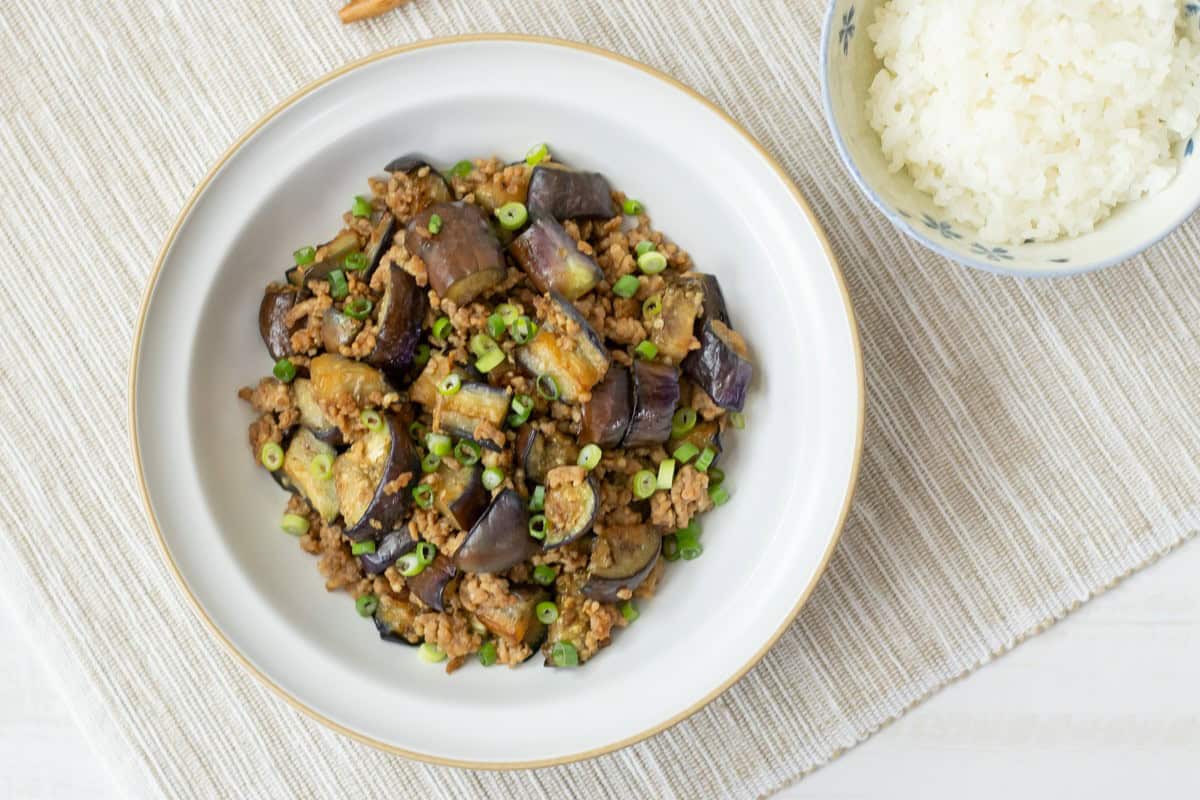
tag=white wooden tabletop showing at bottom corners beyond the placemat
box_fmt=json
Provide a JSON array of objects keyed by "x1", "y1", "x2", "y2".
[{"x1": 0, "y1": 542, "x2": 1200, "y2": 800}]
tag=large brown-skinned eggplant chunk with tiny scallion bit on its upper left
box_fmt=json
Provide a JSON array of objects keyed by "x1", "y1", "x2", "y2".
[{"x1": 404, "y1": 203, "x2": 506, "y2": 306}]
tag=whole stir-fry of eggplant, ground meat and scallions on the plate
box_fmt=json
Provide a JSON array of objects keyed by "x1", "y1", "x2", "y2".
[{"x1": 239, "y1": 145, "x2": 752, "y2": 672}]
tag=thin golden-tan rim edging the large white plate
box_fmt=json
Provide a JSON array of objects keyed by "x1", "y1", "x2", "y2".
[{"x1": 130, "y1": 34, "x2": 866, "y2": 770}]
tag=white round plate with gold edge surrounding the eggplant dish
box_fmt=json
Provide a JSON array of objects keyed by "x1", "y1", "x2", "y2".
[{"x1": 131, "y1": 36, "x2": 863, "y2": 768}]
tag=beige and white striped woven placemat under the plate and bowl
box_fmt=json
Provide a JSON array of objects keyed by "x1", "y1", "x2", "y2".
[{"x1": 0, "y1": 0, "x2": 1200, "y2": 798}]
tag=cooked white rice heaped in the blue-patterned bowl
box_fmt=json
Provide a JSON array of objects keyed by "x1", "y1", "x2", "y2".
[{"x1": 868, "y1": 0, "x2": 1200, "y2": 242}]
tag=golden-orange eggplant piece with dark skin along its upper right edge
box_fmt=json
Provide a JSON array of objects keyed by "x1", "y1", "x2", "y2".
[{"x1": 516, "y1": 291, "x2": 608, "y2": 403}]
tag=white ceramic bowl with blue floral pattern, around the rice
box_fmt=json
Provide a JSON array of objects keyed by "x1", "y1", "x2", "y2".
[{"x1": 821, "y1": 0, "x2": 1200, "y2": 276}]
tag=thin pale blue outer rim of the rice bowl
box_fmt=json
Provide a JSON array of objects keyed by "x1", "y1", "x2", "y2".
[{"x1": 820, "y1": 0, "x2": 1200, "y2": 278}]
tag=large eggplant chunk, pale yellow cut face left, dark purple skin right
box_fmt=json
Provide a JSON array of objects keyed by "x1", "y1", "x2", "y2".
[{"x1": 334, "y1": 414, "x2": 421, "y2": 541}]
